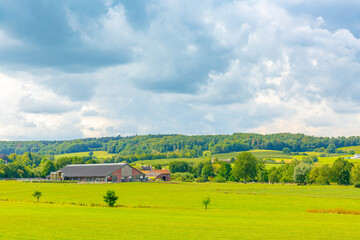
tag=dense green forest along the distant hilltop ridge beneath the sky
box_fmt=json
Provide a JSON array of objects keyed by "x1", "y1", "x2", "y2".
[{"x1": 0, "y1": 133, "x2": 360, "y2": 159}]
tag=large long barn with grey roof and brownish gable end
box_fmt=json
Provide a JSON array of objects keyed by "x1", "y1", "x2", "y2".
[{"x1": 48, "y1": 163, "x2": 146, "y2": 182}]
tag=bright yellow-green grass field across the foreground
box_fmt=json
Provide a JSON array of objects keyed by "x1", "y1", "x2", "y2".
[{"x1": 0, "y1": 182, "x2": 360, "y2": 239}]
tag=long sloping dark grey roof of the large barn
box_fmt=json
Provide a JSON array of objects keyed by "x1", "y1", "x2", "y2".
[{"x1": 59, "y1": 163, "x2": 127, "y2": 177}]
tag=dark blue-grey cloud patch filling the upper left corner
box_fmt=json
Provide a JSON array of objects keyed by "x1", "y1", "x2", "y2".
[{"x1": 0, "y1": 0, "x2": 137, "y2": 72}]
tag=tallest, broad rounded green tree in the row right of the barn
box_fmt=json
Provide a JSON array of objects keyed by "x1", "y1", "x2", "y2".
[{"x1": 232, "y1": 152, "x2": 258, "y2": 183}]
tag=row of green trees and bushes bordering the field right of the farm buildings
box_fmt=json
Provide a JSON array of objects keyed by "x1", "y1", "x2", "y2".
[{"x1": 169, "y1": 152, "x2": 360, "y2": 185}]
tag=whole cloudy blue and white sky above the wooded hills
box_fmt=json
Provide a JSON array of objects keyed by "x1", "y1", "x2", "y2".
[{"x1": 0, "y1": 0, "x2": 360, "y2": 140}]
